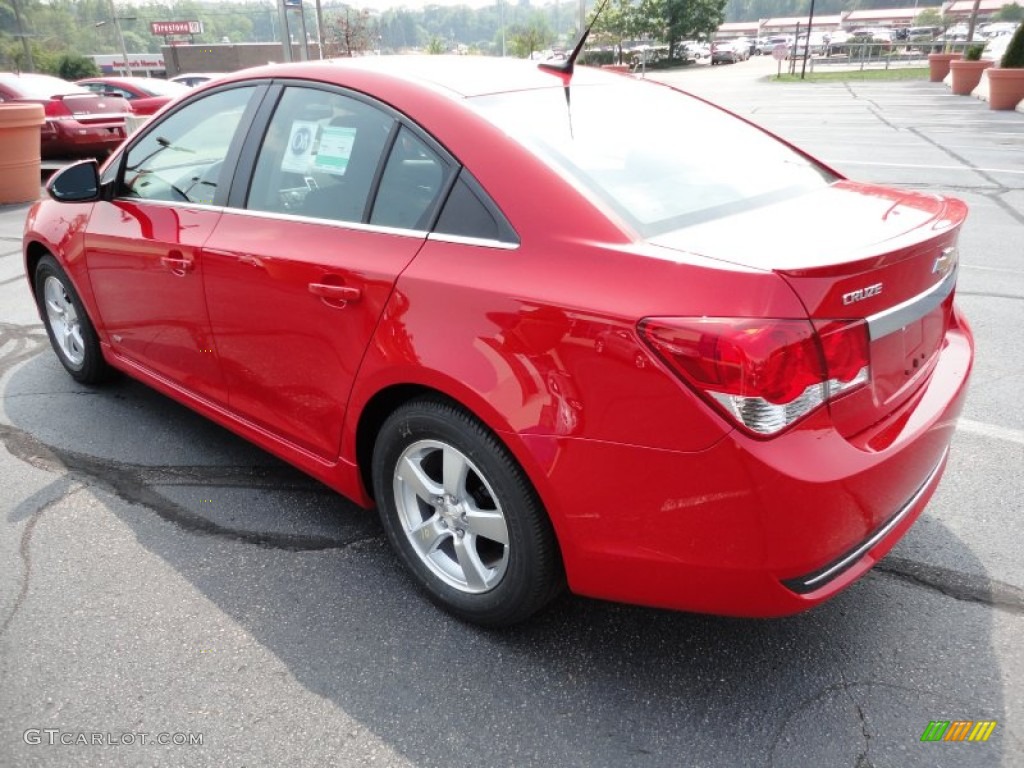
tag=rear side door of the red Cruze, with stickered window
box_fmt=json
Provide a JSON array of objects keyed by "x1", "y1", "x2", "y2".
[{"x1": 202, "y1": 84, "x2": 452, "y2": 460}]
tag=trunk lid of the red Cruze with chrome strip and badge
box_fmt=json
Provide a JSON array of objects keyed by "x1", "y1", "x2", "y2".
[{"x1": 651, "y1": 181, "x2": 967, "y2": 447}]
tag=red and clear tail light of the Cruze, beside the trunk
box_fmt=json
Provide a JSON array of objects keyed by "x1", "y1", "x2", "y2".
[{"x1": 639, "y1": 317, "x2": 870, "y2": 435}]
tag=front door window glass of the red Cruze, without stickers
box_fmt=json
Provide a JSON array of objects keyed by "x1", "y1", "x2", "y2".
[{"x1": 120, "y1": 86, "x2": 255, "y2": 205}]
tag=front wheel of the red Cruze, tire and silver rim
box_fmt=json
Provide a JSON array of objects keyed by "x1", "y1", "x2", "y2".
[{"x1": 33, "y1": 254, "x2": 112, "y2": 384}]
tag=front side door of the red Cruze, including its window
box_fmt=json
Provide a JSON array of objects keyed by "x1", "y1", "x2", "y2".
[{"x1": 85, "y1": 86, "x2": 258, "y2": 402}]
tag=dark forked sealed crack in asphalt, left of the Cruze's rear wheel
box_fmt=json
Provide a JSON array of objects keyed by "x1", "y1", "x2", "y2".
[{"x1": 0, "y1": 424, "x2": 379, "y2": 552}]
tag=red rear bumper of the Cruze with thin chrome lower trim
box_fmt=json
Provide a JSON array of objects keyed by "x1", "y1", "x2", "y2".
[{"x1": 534, "y1": 315, "x2": 973, "y2": 616}]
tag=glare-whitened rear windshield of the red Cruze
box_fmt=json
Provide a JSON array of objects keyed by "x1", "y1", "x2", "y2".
[{"x1": 470, "y1": 78, "x2": 835, "y2": 238}]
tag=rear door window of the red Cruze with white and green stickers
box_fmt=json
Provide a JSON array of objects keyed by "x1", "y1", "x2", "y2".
[{"x1": 246, "y1": 86, "x2": 395, "y2": 222}]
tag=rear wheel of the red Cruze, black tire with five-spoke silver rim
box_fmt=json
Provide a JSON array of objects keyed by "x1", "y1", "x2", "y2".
[{"x1": 373, "y1": 398, "x2": 565, "y2": 627}]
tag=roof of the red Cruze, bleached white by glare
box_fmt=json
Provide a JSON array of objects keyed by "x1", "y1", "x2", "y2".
[{"x1": 212, "y1": 55, "x2": 622, "y2": 97}]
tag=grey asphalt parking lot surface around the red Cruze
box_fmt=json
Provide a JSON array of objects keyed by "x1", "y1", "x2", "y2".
[{"x1": 0, "y1": 59, "x2": 1024, "y2": 768}]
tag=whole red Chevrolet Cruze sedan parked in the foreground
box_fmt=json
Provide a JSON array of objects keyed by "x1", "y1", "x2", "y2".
[{"x1": 25, "y1": 56, "x2": 973, "y2": 626}]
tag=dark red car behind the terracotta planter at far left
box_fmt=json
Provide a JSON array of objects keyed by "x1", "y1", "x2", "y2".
[{"x1": 0, "y1": 73, "x2": 131, "y2": 158}]
